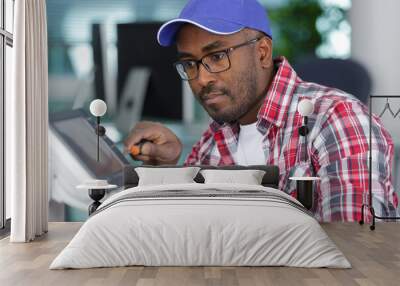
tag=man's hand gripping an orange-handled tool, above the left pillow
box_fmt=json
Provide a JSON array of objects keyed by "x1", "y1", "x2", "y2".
[{"x1": 124, "y1": 121, "x2": 182, "y2": 165}]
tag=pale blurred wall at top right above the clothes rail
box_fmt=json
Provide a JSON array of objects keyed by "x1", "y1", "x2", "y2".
[{"x1": 349, "y1": 0, "x2": 400, "y2": 95}]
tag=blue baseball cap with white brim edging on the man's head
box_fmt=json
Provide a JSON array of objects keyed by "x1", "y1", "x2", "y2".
[{"x1": 157, "y1": 0, "x2": 272, "y2": 47}]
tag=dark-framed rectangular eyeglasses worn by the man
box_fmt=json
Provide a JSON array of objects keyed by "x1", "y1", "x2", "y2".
[{"x1": 174, "y1": 37, "x2": 263, "y2": 80}]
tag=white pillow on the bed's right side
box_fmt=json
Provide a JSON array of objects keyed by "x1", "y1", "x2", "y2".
[{"x1": 200, "y1": 169, "x2": 265, "y2": 185}]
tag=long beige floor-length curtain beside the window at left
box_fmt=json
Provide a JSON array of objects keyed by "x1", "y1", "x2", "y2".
[{"x1": 6, "y1": 0, "x2": 48, "y2": 242}]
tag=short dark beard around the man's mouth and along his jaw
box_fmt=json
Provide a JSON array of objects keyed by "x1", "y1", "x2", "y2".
[{"x1": 197, "y1": 66, "x2": 264, "y2": 124}]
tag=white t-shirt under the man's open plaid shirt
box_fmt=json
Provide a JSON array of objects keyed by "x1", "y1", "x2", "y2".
[{"x1": 213, "y1": 122, "x2": 266, "y2": 166}]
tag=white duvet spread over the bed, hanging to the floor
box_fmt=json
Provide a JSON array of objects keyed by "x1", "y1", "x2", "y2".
[{"x1": 50, "y1": 183, "x2": 351, "y2": 269}]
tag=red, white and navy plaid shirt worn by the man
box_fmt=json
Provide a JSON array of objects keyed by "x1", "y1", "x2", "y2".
[{"x1": 185, "y1": 57, "x2": 398, "y2": 221}]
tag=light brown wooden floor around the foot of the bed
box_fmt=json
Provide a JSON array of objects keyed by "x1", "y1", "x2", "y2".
[{"x1": 0, "y1": 223, "x2": 400, "y2": 286}]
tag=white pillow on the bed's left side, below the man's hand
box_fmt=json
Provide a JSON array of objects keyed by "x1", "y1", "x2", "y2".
[{"x1": 135, "y1": 167, "x2": 200, "y2": 186}]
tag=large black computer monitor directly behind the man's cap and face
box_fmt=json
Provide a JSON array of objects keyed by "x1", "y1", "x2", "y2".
[{"x1": 117, "y1": 23, "x2": 183, "y2": 120}]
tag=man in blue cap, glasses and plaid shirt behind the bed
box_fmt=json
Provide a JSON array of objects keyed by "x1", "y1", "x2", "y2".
[{"x1": 125, "y1": 0, "x2": 397, "y2": 221}]
